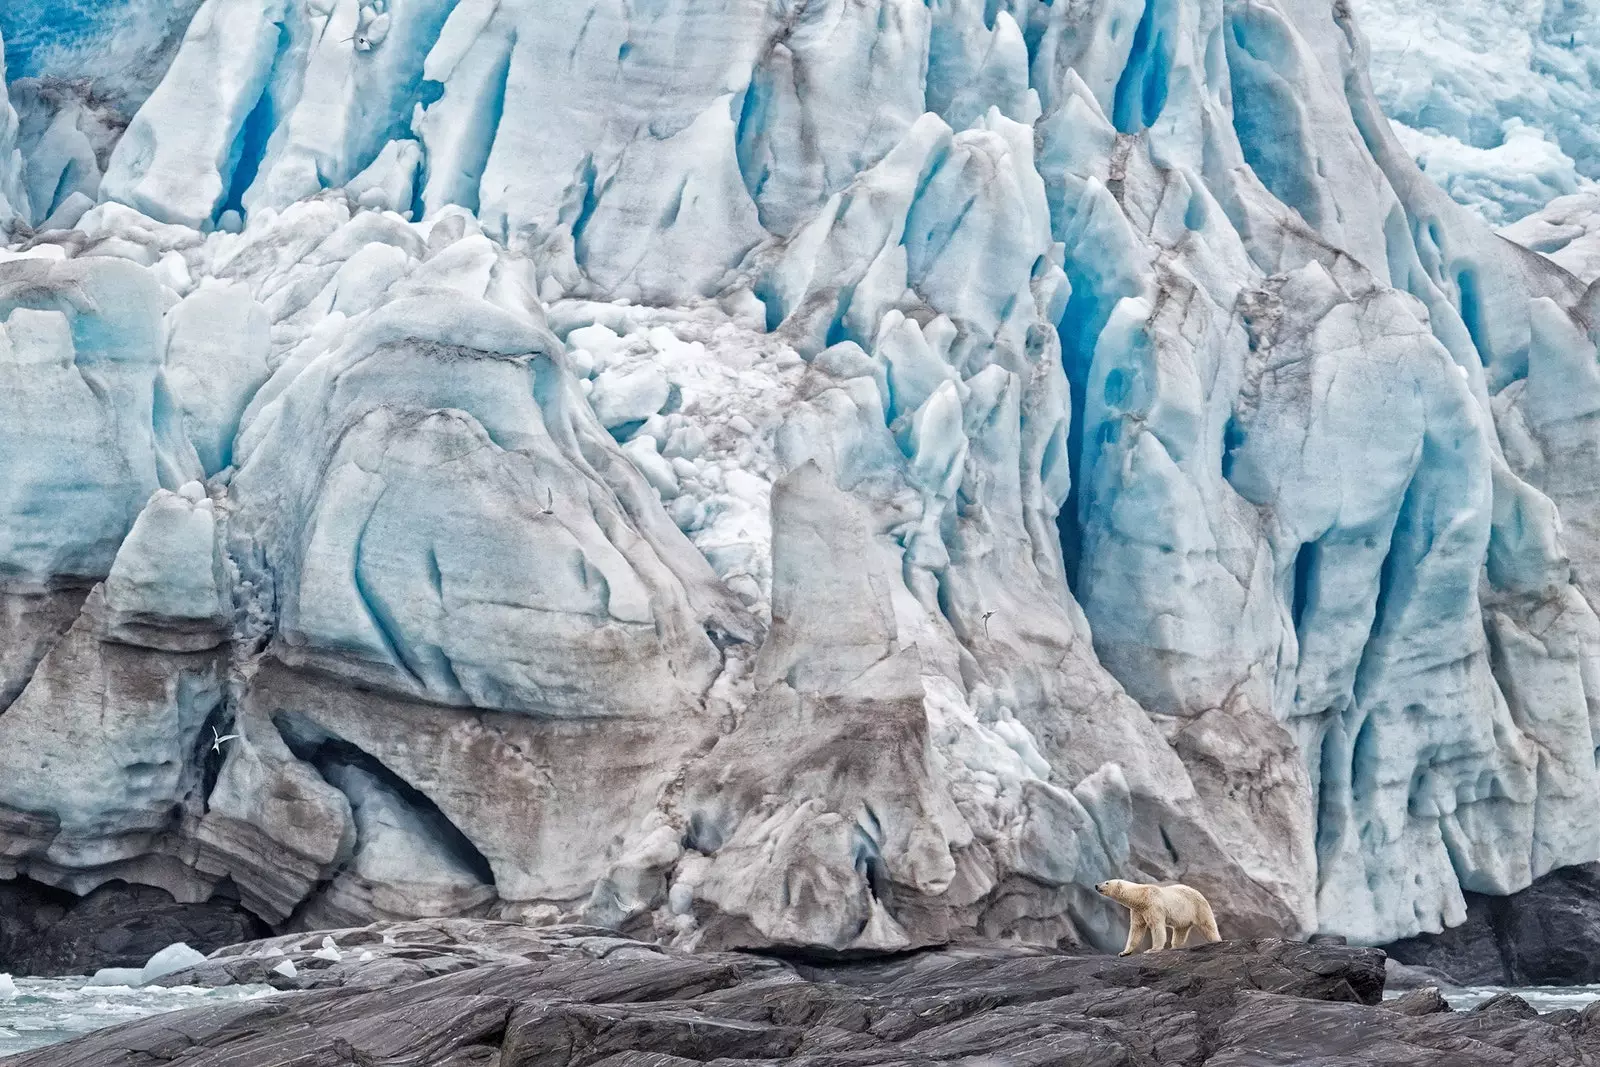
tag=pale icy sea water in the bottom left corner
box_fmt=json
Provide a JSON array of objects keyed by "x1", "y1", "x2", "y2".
[{"x1": 0, "y1": 974, "x2": 275, "y2": 1057}]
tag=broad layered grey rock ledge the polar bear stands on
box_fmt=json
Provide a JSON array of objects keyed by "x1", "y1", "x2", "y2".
[{"x1": 8, "y1": 920, "x2": 1600, "y2": 1067}]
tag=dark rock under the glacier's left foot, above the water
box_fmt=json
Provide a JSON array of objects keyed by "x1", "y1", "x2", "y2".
[{"x1": 0, "y1": 878, "x2": 267, "y2": 977}]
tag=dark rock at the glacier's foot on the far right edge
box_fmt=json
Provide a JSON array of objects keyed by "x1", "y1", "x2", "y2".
[{"x1": 1386, "y1": 864, "x2": 1600, "y2": 985}]
